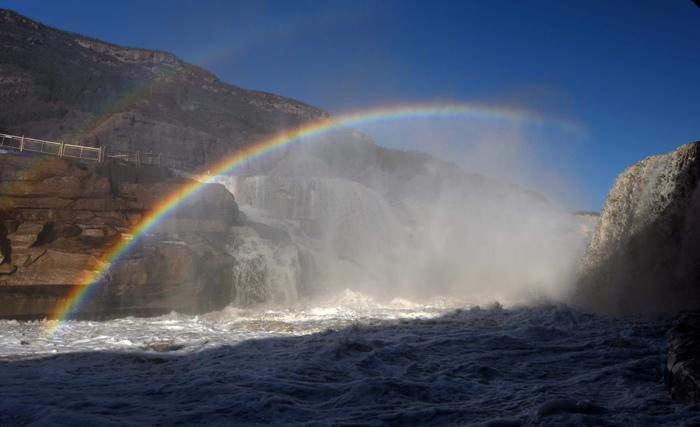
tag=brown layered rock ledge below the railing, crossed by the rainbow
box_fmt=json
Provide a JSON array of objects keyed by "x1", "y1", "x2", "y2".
[{"x1": 0, "y1": 155, "x2": 239, "y2": 318}]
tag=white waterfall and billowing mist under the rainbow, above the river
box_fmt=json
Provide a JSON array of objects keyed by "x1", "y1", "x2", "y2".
[{"x1": 215, "y1": 167, "x2": 585, "y2": 303}]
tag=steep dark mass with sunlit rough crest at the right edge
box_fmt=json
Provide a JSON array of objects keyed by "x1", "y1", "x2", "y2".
[{"x1": 576, "y1": 142, "x2": 700, "y2": 313}]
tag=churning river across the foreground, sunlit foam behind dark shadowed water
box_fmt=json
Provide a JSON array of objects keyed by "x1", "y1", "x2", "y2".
[{"x1": 0, "y1": 291, "x2": 700, "y2": 426}]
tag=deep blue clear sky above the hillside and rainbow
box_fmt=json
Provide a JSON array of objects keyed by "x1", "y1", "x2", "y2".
[{"x1": 0, "y1": 0, "x2": 700, "y2": 209}]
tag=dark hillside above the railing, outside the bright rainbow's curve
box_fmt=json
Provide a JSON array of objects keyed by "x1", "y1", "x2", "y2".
[{"x1": 0, "y1": 9, "x2": 326, "y2": 169}]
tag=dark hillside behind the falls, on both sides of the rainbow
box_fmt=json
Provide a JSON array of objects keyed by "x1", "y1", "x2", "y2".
[{"x1": 0, "y1": 9, "x2": 540, "y2": 203}]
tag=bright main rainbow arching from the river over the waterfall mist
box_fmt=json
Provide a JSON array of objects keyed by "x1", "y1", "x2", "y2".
[{"x1": 46, "y1": 104, "x2": 575, "y2": 335}]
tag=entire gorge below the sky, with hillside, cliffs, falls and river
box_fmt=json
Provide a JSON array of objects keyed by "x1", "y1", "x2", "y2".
[{"x1": 0, "y1": 9, "x2": 700, "y2": 426}]
